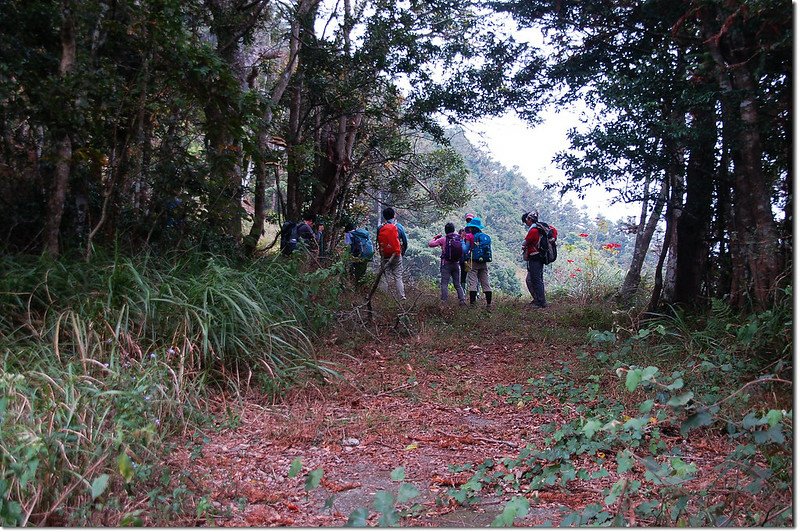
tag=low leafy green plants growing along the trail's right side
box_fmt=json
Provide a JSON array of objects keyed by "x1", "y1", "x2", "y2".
[{"x1": 456, "y1": 298, "x2": 793, "y2": 527}]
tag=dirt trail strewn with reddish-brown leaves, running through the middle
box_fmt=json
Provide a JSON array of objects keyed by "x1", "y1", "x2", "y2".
[{"x1": 174, "y1": 302, "x2": 596, "y2": 527}]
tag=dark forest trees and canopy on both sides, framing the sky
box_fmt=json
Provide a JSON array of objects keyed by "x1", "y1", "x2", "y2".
[{"x1": 0, "y1": 0, "x2": 793, "y2": 307}]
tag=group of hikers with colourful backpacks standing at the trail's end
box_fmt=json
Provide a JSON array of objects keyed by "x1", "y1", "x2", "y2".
[{"x1": 281, "y1": 207, "x2": 558, "y2": 309}]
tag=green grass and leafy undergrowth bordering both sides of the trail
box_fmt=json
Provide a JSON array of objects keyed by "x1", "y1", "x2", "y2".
[{"x1": 0, "y1": 252, "x2": 793, "y2": 526}]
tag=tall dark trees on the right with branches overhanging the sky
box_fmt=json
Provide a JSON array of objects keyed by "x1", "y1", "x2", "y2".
[{"x1": 494, "y1": 0, "x2": 791, "y2": 306}]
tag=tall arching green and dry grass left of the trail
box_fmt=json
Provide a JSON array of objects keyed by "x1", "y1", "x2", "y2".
[{"x1": 0, "y1": 253, "x2": 336, "y2": 526}]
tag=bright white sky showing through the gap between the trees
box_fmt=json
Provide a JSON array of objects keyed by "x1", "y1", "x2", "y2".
[{"x1": 465, "y1": 108, "x2": 640, "y2": 221}]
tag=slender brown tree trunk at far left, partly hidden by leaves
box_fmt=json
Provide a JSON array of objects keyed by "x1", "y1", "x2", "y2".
[{"x1": 44, "y1": 1, "x2": 77, "y2": 257}]
